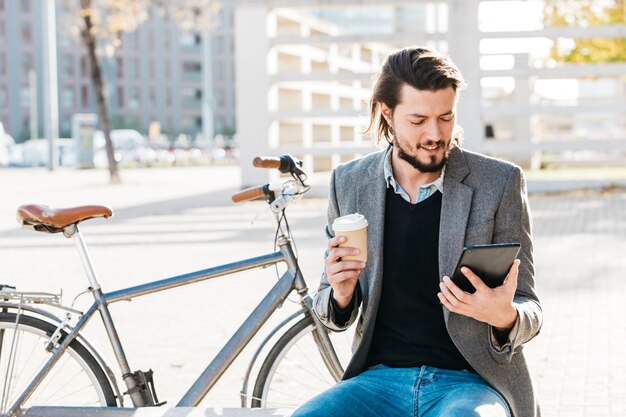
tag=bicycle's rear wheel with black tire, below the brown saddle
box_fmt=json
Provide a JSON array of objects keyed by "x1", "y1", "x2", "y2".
[{"x1": 0, "y1": 312, "x2": 117, "y2": 415}]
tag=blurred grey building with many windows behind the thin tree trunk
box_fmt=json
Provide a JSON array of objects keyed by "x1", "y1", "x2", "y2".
[{"x1": 0, "y1": 0, "x2": 235, "y2": 142}]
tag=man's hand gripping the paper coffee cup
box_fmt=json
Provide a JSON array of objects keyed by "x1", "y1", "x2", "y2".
[{"x1": 324, "y1": 236, "x2": 365, "y2": 309}]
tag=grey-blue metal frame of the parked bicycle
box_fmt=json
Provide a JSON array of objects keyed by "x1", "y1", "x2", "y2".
[{"x1": 8, "y1": 229, "x2": 340, "y2": 416}]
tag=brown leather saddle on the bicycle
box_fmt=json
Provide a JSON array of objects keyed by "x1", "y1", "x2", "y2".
[{"x1": 17, "y1": 204, "x2": 113, "y2": 233}]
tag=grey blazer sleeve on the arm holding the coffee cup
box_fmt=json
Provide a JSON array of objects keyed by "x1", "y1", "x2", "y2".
[{"x1": 313, "y1": 170, "x2": 361, "y2": 332}]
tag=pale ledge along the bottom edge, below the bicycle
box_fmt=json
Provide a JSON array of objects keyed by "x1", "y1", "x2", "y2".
[{"x1": 19, "y1": 406, "x2": 291, "y2": 417}]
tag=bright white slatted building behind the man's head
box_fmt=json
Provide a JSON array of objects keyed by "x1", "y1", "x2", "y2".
[{"x1": 235, "y1": 0, "x2": 626, "y2": 184}]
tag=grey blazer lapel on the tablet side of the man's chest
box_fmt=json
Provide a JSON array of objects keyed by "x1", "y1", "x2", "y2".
[{"x1": 439, "y1": 148, "x2": 473, "y2": 321}]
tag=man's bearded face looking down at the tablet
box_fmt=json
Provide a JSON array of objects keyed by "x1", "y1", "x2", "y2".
[{"x1": 381, "y1": 84, "x2": 456, "y2": 172}]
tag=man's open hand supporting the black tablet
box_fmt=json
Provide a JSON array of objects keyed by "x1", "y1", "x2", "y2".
[{"x1": 437, "y1": 259, "x2": 520, "y2": 330}]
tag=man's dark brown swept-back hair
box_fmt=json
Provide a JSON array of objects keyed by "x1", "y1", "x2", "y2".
[{"x1": 365, "y1": 46, "x2": 465, "y2": 145}]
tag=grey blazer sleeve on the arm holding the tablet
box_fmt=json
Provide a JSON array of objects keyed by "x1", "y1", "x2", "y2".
[{"x1": 490, "y1": 167, "x2": 543, "y2": 362}]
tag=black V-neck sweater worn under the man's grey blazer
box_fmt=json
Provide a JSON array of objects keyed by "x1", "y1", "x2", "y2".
[{"x1": 368, "y1": 187, "x2": 471, "y2": 370}]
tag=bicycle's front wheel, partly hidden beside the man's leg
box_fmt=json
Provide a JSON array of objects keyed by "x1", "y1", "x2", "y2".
[{"x1": 251, "y1": 317, "x2": 345, "y2": 409}]
